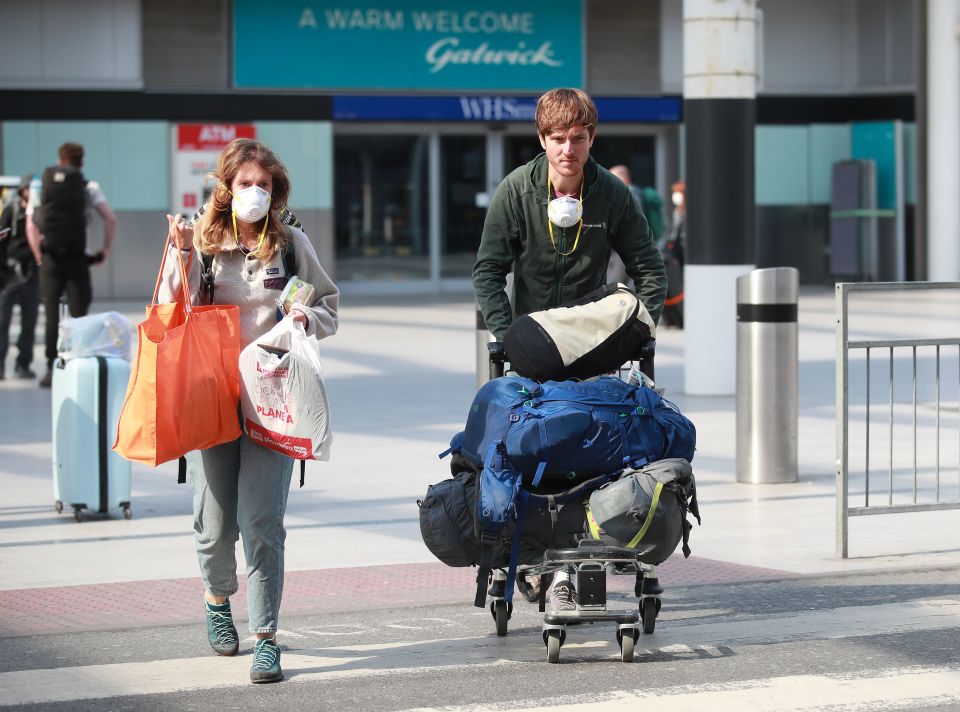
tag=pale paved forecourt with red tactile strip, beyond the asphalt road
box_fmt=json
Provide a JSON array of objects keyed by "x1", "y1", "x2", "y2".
[{"x1": 0, "y1": 280, "x2": 960, "y2": 709}]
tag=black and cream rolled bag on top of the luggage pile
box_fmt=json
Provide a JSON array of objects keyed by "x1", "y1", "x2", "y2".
[{"x1": 503, "y1": 284, "x2": 657, "y2": 381}]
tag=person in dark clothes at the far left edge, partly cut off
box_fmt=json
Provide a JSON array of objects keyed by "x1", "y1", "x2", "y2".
[{"x1": 0, "y1": 175, "x2": 40, "y2": 380}]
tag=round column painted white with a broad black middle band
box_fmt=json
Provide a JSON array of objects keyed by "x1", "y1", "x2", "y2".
[{"x1": 683, "y1": 0, "x2": 757, "y2": 395}]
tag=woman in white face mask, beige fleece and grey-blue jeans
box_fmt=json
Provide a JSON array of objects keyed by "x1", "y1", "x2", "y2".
[{"x1": 159, "y1": 139, "x2": 340, "y2": 683}]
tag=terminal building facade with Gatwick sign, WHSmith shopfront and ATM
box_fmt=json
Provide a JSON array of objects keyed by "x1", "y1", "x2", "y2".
[{"x1": 0, "y1": 0, "x2": 923, "y2": 299}]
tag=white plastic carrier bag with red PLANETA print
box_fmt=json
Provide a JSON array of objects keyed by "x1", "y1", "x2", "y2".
[{"x1": 240, "y1": 317, "x2": 333, "y2": 460}]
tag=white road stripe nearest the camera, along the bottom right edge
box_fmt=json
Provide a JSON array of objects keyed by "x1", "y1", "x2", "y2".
[{"x1": 407, "y1": 667, "x2": 960, "y2": 712}]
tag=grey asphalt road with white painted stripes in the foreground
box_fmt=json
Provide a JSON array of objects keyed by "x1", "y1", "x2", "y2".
[{"x1": 0, "y1": 570, "x2": 960, "y2": 712}]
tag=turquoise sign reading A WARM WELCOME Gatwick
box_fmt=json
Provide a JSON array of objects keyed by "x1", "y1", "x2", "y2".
[{"x1": 233, "y1": 0, "x2": 583, "y2": 91}]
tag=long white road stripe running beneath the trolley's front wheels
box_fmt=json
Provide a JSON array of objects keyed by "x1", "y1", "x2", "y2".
[{"x1": 0, "y1": 599, "x2": 960, "y2": 712}]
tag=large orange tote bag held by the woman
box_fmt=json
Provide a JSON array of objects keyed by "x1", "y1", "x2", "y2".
[{"x1": 113, "y1": 246, "x2": 240, "y2": 466}]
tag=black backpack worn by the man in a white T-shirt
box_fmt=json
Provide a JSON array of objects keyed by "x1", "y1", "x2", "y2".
[{"x1": 33, "y1": 165, "x2": 87, "y2": 257}]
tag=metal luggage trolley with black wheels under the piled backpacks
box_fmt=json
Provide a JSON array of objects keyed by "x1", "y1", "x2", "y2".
[{"x1": 488, "y1": 340, "x2": 663, "y2": 663}]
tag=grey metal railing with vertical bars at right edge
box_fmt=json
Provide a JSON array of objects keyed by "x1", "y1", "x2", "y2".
[{"x1": 836, "y1": 282, "x2": 960, "y2": 559}]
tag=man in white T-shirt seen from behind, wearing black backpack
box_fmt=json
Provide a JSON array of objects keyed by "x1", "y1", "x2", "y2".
[{"x1": 27, "y1": 143, "x2": 117, "y2": 388}]
